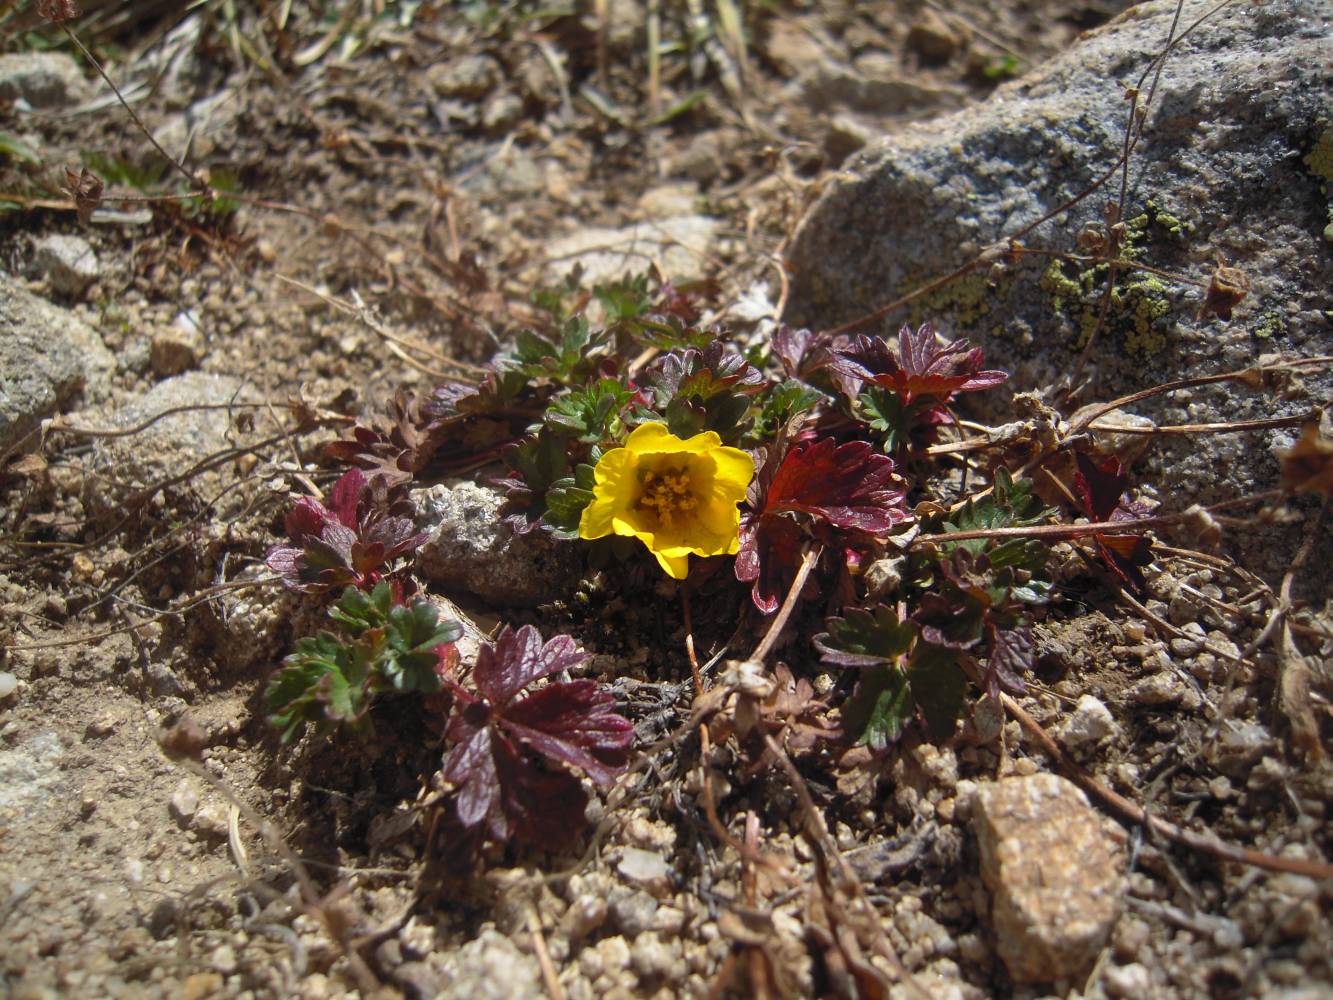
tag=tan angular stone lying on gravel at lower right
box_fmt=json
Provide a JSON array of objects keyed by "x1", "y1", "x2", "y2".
[{"x1": 973, "y1": 773, "x2": 1125, "y2": 983}]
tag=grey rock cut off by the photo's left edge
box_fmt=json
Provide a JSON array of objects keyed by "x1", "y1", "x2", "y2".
[{"x1": 0, "y1": 272, "x2": 116, "y2": 456}]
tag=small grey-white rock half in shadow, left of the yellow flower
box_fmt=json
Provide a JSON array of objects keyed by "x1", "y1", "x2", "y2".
[{"x1": 412, "y1": 483, "x2": 581, "y2": 607}]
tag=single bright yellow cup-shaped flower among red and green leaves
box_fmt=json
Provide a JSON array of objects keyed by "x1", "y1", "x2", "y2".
[{"x1": 579, "y1": 424, "x2": 754, "y2": 580}]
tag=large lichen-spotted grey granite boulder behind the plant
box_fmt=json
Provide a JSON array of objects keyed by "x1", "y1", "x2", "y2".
[{"x1": 786, "y1": 0, "x2": 1333, "y2": 525}]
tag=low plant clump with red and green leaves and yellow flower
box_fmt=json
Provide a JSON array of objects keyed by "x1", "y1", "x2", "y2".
[{"x1": 257, "y1": 276, "x2": 1210, "y2": 857}]
